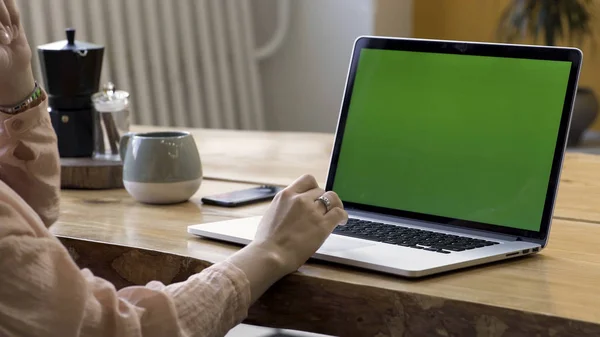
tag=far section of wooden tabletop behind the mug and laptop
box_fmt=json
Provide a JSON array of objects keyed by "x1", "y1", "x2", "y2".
[{"x1": 133, "y1": 126, "x2": 600, "y2": 223}]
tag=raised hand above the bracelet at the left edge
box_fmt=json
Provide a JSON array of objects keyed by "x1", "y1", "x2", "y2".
[{"x1": 0, "y1": 0, "x2": 35, "y2": 106}]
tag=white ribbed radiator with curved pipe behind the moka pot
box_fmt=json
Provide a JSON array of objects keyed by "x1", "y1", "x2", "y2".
[{"x1": 18, "y1": 0, "x2": 290, "y2": 130}]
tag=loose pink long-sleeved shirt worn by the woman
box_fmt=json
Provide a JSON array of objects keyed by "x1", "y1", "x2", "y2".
[{"x1": 0, "y1": 98, "x2": 251, "y2": 337}]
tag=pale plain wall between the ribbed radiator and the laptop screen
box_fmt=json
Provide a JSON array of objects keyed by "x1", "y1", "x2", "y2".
[{"x1": 255, "y1": 0, "x2": 374, "y2": 132}]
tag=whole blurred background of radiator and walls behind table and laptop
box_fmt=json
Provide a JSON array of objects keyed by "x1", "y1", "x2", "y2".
[{"x1": 14, "y1": 0, "x2": 600, "y2": 145}]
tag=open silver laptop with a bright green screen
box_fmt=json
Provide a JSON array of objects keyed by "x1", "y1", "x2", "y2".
[{"x1": 188, "y1": 36, "x2": 582, "y2": 277}]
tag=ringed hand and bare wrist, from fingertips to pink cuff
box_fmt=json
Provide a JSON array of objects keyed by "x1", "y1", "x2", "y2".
[{"x1": 229, "y1": 176, "x2": 348, "y2": 302}]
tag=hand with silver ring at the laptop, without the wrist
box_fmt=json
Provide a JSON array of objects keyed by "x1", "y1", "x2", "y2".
[{"x1": 253, "y1": 175, "x2": 348, "y2": 273}]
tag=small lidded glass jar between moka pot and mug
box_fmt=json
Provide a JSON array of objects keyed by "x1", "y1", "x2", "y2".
[{"x1": 92, "y1": 82, "x2": 130, "y2": 161}]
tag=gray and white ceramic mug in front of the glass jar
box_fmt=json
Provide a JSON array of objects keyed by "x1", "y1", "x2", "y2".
[{"x1": 120, "y1": 132, "x2": 202, "y2": 204}]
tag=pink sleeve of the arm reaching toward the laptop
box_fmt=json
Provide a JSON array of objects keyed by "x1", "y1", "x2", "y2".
[{"x1": 0, "y1": 188, "x2": 250, "y2": 337}]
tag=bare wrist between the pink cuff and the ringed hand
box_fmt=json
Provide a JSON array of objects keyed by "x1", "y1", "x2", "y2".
[{"x1": 229, "y1": 243, "x2": 292, "y2": 303}]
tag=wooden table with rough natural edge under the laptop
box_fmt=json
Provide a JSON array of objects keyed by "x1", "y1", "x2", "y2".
[{"x1": 51, "y1": 127, "x2": 600, "y2": 336}]
